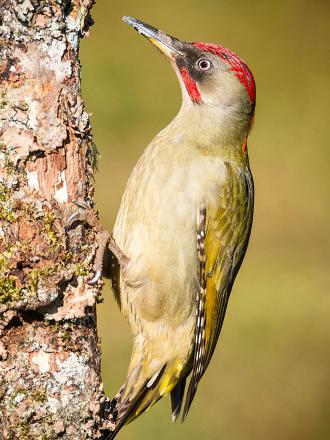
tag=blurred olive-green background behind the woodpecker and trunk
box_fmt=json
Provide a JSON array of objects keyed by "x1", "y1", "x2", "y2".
[{"x1": 81, "y1": 0, "x2": 330, "y2": 440}]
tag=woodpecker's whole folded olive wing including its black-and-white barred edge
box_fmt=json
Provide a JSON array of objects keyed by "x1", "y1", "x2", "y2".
[{"x1": 183, "y1": 164, "x2": 254, "y2": 420}]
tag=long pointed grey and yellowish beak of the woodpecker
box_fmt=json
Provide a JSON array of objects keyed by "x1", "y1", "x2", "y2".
[{"x1": 123, "y1": 17, "x2": 183, "y2": 61}]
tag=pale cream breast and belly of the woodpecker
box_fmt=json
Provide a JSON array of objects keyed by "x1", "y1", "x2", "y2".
[{"x1": 114, "y1": 138, "x2": 226, "y2": 328}]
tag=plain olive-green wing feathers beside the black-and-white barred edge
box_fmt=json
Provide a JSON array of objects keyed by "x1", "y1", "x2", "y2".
[{"x1": 204, "y1": 167, "x2": 254, "y2": 370}]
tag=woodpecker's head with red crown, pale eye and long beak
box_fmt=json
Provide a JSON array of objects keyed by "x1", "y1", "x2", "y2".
[{"x1": 123, "y1": 17, "x2": 256, "y2": 150}]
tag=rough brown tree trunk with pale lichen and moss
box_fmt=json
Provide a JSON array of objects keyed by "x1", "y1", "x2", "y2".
[{"x1": 0, "y1": 0, "x2": 111, "y2": 440}]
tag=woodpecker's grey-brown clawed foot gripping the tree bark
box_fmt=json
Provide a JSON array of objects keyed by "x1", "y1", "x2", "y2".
[{"x1": 65, "y1": 201, "x2": 110, "y2": 285}]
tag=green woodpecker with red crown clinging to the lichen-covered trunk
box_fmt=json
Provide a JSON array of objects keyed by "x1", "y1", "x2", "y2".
[{"x1": 109, "y1": 17, "x2": 255, "y2": 439}]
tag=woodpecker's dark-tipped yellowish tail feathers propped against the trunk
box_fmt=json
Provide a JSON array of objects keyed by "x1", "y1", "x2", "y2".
[{"x1": 107, "y1": 356, "x2": 185, "y2": 440}]
